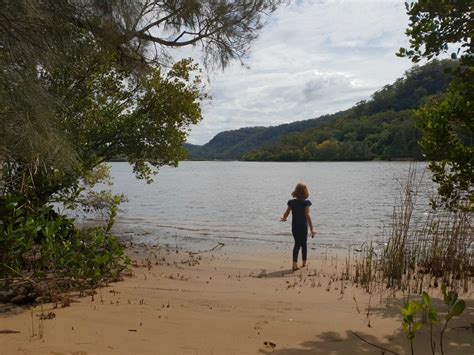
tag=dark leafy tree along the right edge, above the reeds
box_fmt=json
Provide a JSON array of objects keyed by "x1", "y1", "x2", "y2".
[{"x1": 398, "y1": 0, "x2": 474, "y2": 209}]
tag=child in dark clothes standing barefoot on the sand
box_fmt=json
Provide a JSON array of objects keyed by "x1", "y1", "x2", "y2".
[{"x1": 280, "y1": 183, "x2": 316, "y2": 270}]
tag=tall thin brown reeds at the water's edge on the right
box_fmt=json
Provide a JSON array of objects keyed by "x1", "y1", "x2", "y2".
[{"x1": 353, "y1": 167, "x2": 474, "y2": 293}]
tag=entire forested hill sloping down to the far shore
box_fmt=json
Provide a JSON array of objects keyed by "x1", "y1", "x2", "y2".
[{"x1": 185, "y1": 60, "x2": 457, "y2": 161}]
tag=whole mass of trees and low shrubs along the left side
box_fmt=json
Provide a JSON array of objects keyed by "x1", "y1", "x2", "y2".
[{"x1": 0, "y1": 0, "x2": 280, "y2": 298}]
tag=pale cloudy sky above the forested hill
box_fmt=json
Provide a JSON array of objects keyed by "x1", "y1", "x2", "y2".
[{"x1": 181, "y1": 0, "x2": 411, "y2": 144}]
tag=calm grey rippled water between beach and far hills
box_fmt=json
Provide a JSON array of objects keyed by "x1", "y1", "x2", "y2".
[{"x1": 106, "y1": 162, "x2": 432, "y2": 252}]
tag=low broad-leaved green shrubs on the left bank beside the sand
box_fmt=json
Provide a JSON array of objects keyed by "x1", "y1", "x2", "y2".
[{"x1": 0, "y1": 165, "x2": 128, "y2": 292}]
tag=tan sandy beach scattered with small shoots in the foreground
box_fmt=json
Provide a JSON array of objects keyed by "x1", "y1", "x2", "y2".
[{"x1": 0, "y1": 246, "x2": 474, "y2": 355}]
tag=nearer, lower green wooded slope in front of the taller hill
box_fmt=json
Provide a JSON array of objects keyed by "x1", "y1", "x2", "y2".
[{"x1": 243, "y1": 111, "x2": 421, "y2": 161}]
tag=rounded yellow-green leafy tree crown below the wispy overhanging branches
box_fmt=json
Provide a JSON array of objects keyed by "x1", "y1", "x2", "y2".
[{"x1": 43, "y1": 42, "x2": 206, "y2": 185}]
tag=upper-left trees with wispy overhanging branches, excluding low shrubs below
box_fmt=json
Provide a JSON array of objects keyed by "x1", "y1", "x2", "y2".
[{"x1": 0, "y1": 0, "x2": 281, "y2": 203}]
